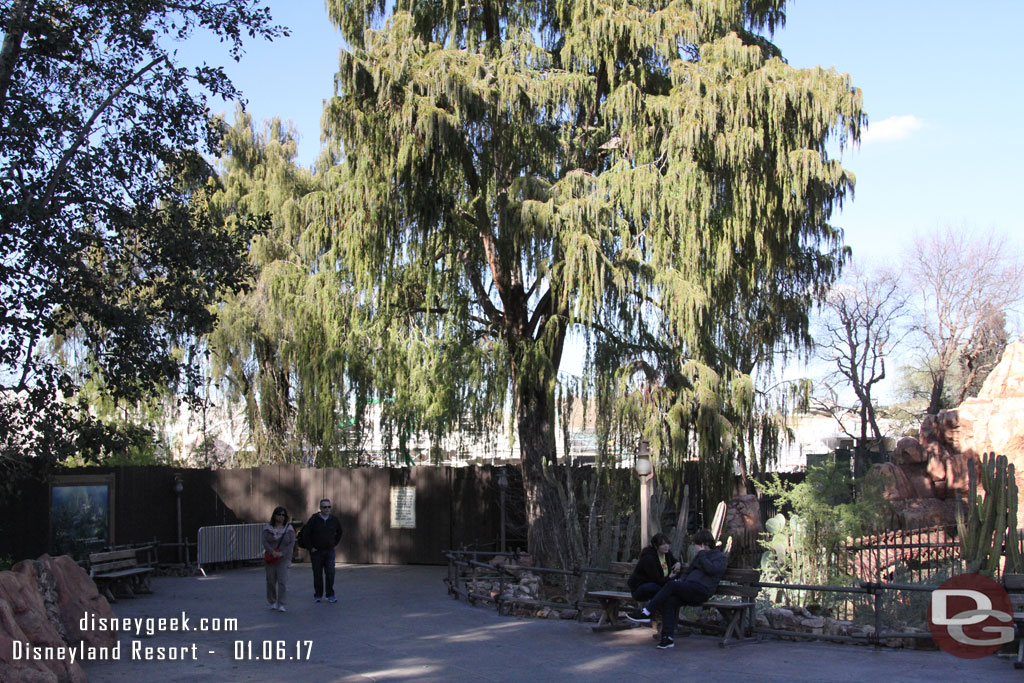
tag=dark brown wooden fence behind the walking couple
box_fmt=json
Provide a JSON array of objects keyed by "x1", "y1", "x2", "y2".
[{"x1": 0, "y1": 465, "x2": 524, "y2": 564}]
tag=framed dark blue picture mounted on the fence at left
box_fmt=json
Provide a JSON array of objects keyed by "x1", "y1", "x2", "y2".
[{"x1": 50, "y1": 474, "x2": 114, "y2": 559}]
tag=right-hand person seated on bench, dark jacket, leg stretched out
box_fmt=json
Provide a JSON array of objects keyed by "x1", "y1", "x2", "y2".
[{"x1": 627, "y1": 529, "x2": 728, "y2": 649}]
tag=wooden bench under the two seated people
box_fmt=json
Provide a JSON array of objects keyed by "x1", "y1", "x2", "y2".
[{"x1": 587, "y1": 562, "x2": 761, "y2": 647}]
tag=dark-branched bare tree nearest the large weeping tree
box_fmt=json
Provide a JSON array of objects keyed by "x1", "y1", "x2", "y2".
[{"x1": 817, "y1": 268, "x2": 907, "y2": 445}]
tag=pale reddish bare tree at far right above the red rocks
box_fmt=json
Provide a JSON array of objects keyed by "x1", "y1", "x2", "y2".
[{"x1": 907, "y1": 225, "x2": 1024, "y2": 415}]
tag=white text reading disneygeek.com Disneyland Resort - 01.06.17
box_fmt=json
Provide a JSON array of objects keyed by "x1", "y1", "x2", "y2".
[{"x1": 11, "y1": 612, "x2": 313, "y2": 664}]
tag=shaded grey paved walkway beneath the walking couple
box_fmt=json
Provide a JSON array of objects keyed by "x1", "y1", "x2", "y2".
[{"x1": 85, "y1": 564, "x2": 1024, "y2": 683}]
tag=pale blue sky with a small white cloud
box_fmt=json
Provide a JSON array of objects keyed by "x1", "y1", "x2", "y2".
[{"x1": 180, "y1": 0, "x2": 1024, "y2": 265}]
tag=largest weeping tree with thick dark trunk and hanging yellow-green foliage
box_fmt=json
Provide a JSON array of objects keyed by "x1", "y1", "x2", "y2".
[{"x1": 308, "y1": 0, "x2": 863, "y2": 558}]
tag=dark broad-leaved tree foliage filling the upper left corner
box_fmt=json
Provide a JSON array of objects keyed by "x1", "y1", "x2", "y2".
[{"x1": 0, "y1": 0, "x2": 281, "y2": 459}]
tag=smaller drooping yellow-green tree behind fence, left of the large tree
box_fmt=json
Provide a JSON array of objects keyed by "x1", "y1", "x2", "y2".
[{"x1": 209, "y1": 110, "x2": 344, "y2": 464}]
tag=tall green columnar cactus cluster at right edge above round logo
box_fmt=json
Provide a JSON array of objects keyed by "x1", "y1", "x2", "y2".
[{"x1": 956, "y1": 453, "x2": 1022, "y2": 577}]
